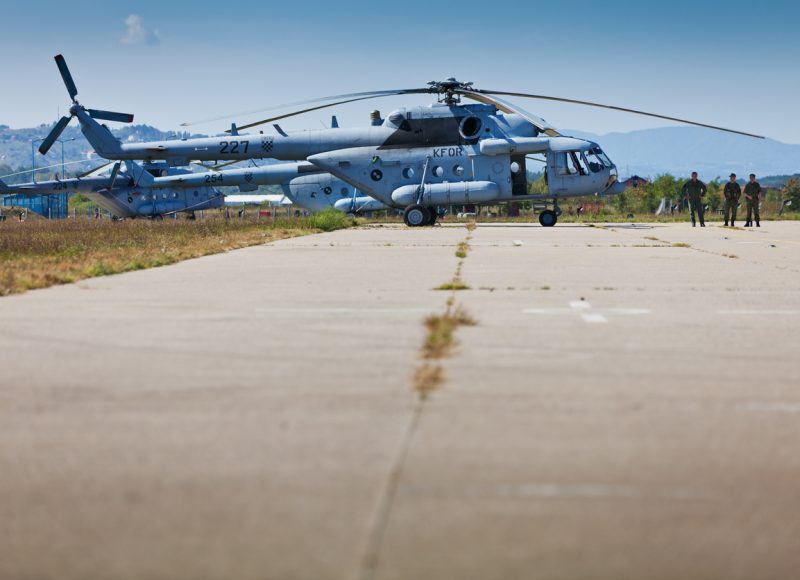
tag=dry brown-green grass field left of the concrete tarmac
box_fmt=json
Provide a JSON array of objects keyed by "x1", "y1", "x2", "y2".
[{"x1": 0, "y1": 210, "x2": 353, "y2": 296}]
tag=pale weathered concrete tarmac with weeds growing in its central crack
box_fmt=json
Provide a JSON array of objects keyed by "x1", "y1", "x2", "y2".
[{"x1": 0, "y1": 222, "x2": 800, "y2": 580}]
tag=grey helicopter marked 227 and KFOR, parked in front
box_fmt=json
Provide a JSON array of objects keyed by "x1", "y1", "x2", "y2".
[{"x1": 40, "y1": 55, "x2": 763, "y2": 226}]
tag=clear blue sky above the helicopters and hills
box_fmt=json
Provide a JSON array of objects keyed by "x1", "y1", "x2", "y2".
[{"x1": 0, "y1": 0, "x2": 800, "y2": 143}]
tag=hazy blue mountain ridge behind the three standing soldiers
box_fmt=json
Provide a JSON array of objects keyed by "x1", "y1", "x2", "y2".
[{"x1": 564, "y1": 127, "x2": 800, "y2": 180}]
